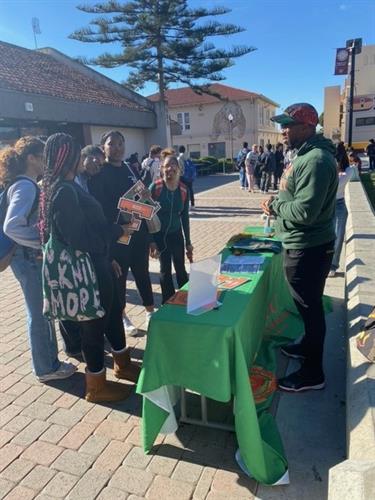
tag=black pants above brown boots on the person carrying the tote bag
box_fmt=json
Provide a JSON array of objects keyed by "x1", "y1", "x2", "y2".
[{"x1": 79, "y1": 258, "x2": 126, "y2": 372}]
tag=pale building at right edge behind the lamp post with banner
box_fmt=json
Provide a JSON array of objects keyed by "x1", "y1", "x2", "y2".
[{"x1": 324, "y1": 45, "x2": 375, "y2": 149}]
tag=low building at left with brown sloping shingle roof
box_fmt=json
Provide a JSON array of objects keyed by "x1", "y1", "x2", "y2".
[{"x1": 0, "y1": 42, "x2": 170, "y2": 155}]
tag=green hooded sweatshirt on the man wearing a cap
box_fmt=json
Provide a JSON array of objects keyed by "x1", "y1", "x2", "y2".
[{"x1": 270, "y1": 134, "x2": 338, "y2": 249}]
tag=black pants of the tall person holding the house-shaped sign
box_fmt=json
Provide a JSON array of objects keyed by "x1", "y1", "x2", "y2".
[{"x1": 114, "y1": 231, "x2": 154, "y2": 309}]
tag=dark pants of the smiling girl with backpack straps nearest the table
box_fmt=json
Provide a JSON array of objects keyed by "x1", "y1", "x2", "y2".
[{"x1": 155, "y1": 231, "x2": 189, "y2": 304}]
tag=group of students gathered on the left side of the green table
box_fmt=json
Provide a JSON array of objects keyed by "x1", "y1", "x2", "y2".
[{"x1": 0, "y1": 130, "x2": 194, "y2": 402}]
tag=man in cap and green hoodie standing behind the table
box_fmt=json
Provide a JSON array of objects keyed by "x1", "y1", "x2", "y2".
[{"x1": 262, "y1": 103, "x2": 338, "y2": 392}]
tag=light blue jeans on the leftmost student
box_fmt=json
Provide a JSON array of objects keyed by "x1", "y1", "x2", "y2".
[{"x1": 10, "y1": 246, "x2": 60, "y2": 377}]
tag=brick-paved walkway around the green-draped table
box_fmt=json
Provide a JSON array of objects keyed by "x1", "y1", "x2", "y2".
[{"x1": 0, "y1": 175, "x2": 344, "y2": 500}]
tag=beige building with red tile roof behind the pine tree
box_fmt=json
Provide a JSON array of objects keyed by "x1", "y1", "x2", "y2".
[{"x1": 149, "y1": 83, "x2": 279, "y2": 158}]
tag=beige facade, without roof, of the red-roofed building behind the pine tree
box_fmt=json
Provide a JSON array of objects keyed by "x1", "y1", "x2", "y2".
[{"x1": 169, "y1": 99, "x2": 279, "y2": 158}]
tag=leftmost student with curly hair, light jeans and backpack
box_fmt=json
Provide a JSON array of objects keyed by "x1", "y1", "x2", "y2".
[{"x1": 0, "y1": 137, "x2": 76, "y2": 382}]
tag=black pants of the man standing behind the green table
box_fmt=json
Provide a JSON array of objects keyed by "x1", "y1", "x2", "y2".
[{"x1": 284, "y1": 241, "x2": 334, "y2": 375}]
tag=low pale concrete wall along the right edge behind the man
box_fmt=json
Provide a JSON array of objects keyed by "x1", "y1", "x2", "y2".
[{"x1": 328, "y1": 182, "x2": 375, "y2": 500}]
